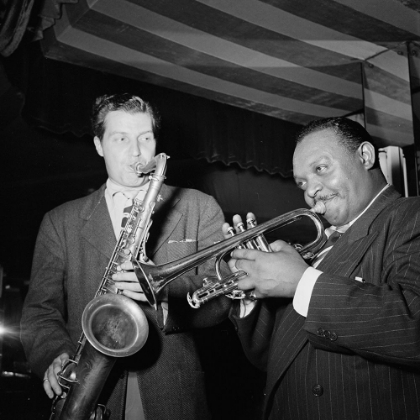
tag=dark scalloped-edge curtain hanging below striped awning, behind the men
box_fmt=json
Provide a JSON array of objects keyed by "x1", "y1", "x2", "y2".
[{"x1": 19, "y1": 45, "x2": 300, "y2": 177}]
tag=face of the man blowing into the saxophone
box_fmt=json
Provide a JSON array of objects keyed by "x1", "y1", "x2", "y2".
[{"x1": 94, "y1": 111, "x2": 156, "y2": 187}]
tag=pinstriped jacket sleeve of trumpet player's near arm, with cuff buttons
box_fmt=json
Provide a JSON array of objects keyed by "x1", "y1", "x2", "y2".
[{"x1": 304, "y1": 199, "x2": 420, "y2": 367}]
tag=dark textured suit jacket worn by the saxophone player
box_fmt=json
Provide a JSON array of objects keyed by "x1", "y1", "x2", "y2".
[{"x1": 21, "y1": 185, "x2": 229, "y2": 420}]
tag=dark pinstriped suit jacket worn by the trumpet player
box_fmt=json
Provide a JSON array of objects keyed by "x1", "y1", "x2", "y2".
[{"x1": 232, "y1": 187, "x2": 420, "y2": 420}]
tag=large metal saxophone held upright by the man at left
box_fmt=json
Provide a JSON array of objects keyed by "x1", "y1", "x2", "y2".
[{"x1": 50, "y1": 153, "x2": 168, "y2": 420}]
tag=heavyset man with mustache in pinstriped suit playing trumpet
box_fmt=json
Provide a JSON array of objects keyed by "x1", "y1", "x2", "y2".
[{"x1": 223, "y1": 118, "x2": 420, "y2": 420}]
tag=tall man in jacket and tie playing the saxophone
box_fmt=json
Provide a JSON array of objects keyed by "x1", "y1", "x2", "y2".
[{"x1": 21, "y1": 94, "x2": 229, "y2": 420}]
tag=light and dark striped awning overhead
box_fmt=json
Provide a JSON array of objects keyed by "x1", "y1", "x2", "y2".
[{"x1": 38, "y1": 0, "x2": 420, "y2": 146}]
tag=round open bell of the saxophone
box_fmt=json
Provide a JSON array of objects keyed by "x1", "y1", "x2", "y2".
[{"x1": 82, "y1": 293, "x2": 149, "y2": 357}]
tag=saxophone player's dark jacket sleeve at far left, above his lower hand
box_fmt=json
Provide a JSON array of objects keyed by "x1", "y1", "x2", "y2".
[{"x1": 21, "y1": 214, "x2": 75, "y2": 377}]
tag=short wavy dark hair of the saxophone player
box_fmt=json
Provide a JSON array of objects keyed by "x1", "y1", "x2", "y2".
[{"x1": 91, "y1": 93, "x2": 160, "y2": 140}]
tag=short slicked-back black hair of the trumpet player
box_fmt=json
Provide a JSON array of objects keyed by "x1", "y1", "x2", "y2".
[{"x1": 296, "y1": 117, "x2": 379, "y2": 167}]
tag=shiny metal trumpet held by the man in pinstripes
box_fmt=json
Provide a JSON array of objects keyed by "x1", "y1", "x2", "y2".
[{"x1": 132, "y1": 208, "x2": 326, "y2": 309}]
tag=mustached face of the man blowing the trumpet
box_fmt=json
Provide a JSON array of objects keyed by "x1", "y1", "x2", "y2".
[{"x1": 293, "y1": 129, "x2": 373, "y2": 226}]
